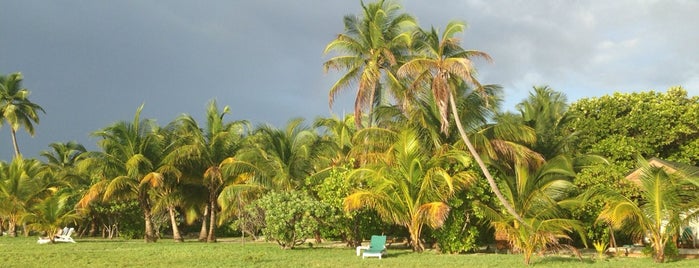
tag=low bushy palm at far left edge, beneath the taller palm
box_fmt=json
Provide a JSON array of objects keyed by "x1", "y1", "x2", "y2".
[{"x1": 0, "y1": 156, "x2": 52, "y2": 237}]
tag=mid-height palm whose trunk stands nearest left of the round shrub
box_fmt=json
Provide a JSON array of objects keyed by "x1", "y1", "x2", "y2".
[{"x1": 166, "y1": 101, "x2": 249, "y2": 242}]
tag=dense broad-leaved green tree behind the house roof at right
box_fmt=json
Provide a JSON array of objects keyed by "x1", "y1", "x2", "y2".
[{"x1": 567, "y1": 87, "x2": 699, "y2": 166}]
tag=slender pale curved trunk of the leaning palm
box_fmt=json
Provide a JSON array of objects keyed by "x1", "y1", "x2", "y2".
[{"x1": 449, "y1": 91, "x2": 529, "y2": 226}]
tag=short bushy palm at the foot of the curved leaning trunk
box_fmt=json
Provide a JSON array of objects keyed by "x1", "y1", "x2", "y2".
[{"x1": 481, "y1": 156, "x2": 584, "y2": 265}]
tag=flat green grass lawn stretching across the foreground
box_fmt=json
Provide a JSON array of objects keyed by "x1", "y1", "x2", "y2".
[{"x1": 0, "y1": 236, "x2": 699, "y2": 268}]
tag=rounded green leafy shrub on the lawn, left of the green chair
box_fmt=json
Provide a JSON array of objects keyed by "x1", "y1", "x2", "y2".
[{"x1": 247, "y1": 191, "x2": 329, "y2": 249}]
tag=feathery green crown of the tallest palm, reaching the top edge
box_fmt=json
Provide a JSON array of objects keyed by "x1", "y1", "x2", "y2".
[{"x1": 323, "y1": 0, "x2": 416, "y2": 128}]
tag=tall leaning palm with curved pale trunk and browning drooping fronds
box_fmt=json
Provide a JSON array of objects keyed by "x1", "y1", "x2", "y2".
[{"x1": 398, "y1": 21, "x2": 524, "y2": 223}]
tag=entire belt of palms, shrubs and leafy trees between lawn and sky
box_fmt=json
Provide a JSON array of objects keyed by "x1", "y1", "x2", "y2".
[{"x1": 0, "y1": 0, "x2": 699, "y2": 263}]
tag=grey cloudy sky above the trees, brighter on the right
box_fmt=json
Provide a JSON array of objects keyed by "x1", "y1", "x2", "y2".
[{"x1": 0, "y1": 0, "x2": 699, "y2": 159}]
